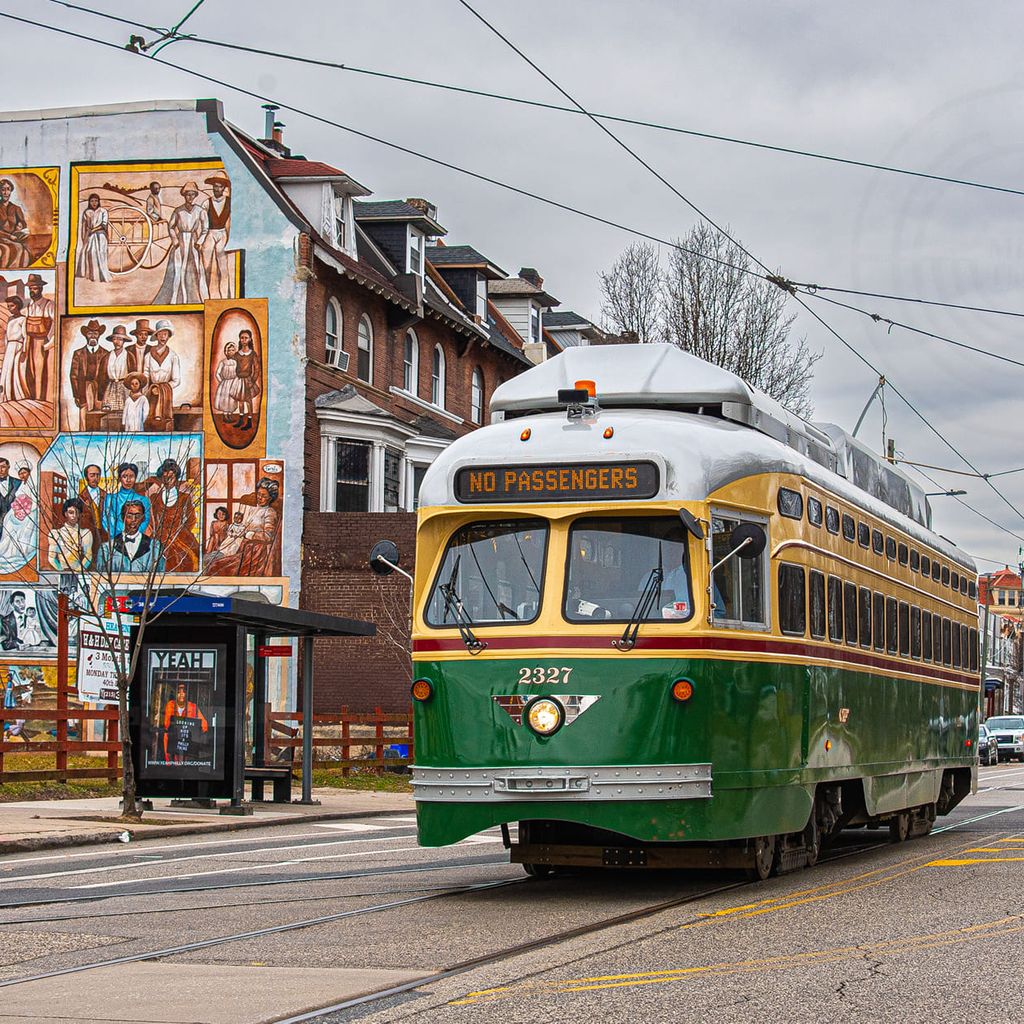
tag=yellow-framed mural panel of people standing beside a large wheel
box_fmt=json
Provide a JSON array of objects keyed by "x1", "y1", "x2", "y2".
[{"x1": 68, "y1": 160, "x2": 242, "y2": 315}]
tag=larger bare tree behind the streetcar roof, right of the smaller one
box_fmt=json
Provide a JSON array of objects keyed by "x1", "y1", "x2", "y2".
[{"x1": 665, "y1": 223, "x2": 821, "y2": 417}]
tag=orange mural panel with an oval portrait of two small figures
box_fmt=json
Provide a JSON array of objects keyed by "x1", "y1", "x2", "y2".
[{"x1": 205, "y1": 299, "x2": 267, "y2": 457}]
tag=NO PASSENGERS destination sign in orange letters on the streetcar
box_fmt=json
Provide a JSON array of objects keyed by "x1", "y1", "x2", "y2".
[{"x1": 455, "y1": 462, "x2": 658, "y2": 503}]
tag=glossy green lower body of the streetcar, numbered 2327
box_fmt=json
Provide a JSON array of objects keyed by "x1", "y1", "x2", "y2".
[{"x1": 414, "y1": 653, "x2": 977, "y2": 846}]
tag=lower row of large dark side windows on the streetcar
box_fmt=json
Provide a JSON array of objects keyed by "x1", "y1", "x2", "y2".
[{"x1": 778, "y1": 562, "x2": 978, "y2": 672}]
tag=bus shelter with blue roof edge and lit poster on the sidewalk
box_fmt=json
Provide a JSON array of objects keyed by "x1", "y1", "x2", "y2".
[{"x1": 125, "y1": 594, "x2": 377, "y2": 809}]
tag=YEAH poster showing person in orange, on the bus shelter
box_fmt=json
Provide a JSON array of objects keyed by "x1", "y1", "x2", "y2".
[{"x1": 139, "y1": 644, "x2": 226, "y2": 780}]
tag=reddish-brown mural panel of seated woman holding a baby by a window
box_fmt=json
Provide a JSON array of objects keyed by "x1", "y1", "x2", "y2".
[{"x1": 203, "y1": 459, "x2": 285, "y2": 577}]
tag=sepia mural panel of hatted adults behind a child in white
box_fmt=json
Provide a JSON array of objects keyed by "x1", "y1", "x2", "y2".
[{"x1": 60, "y1": 313, "x2": 203, "y2": 433}]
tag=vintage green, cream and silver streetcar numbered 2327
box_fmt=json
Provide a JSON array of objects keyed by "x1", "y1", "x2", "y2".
[{"x1": 389, "y1": 344, "x2": 979, "y2": 879}]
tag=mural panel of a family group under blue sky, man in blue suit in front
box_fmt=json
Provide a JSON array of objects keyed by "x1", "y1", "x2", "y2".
[{"x1": 39, "y1": 434, "x2": 203, "y2": 575}]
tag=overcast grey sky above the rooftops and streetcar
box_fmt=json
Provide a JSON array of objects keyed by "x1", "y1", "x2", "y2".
[{"x1": 0, "y1": 0, "x2": 1024, "y2": 571}]
